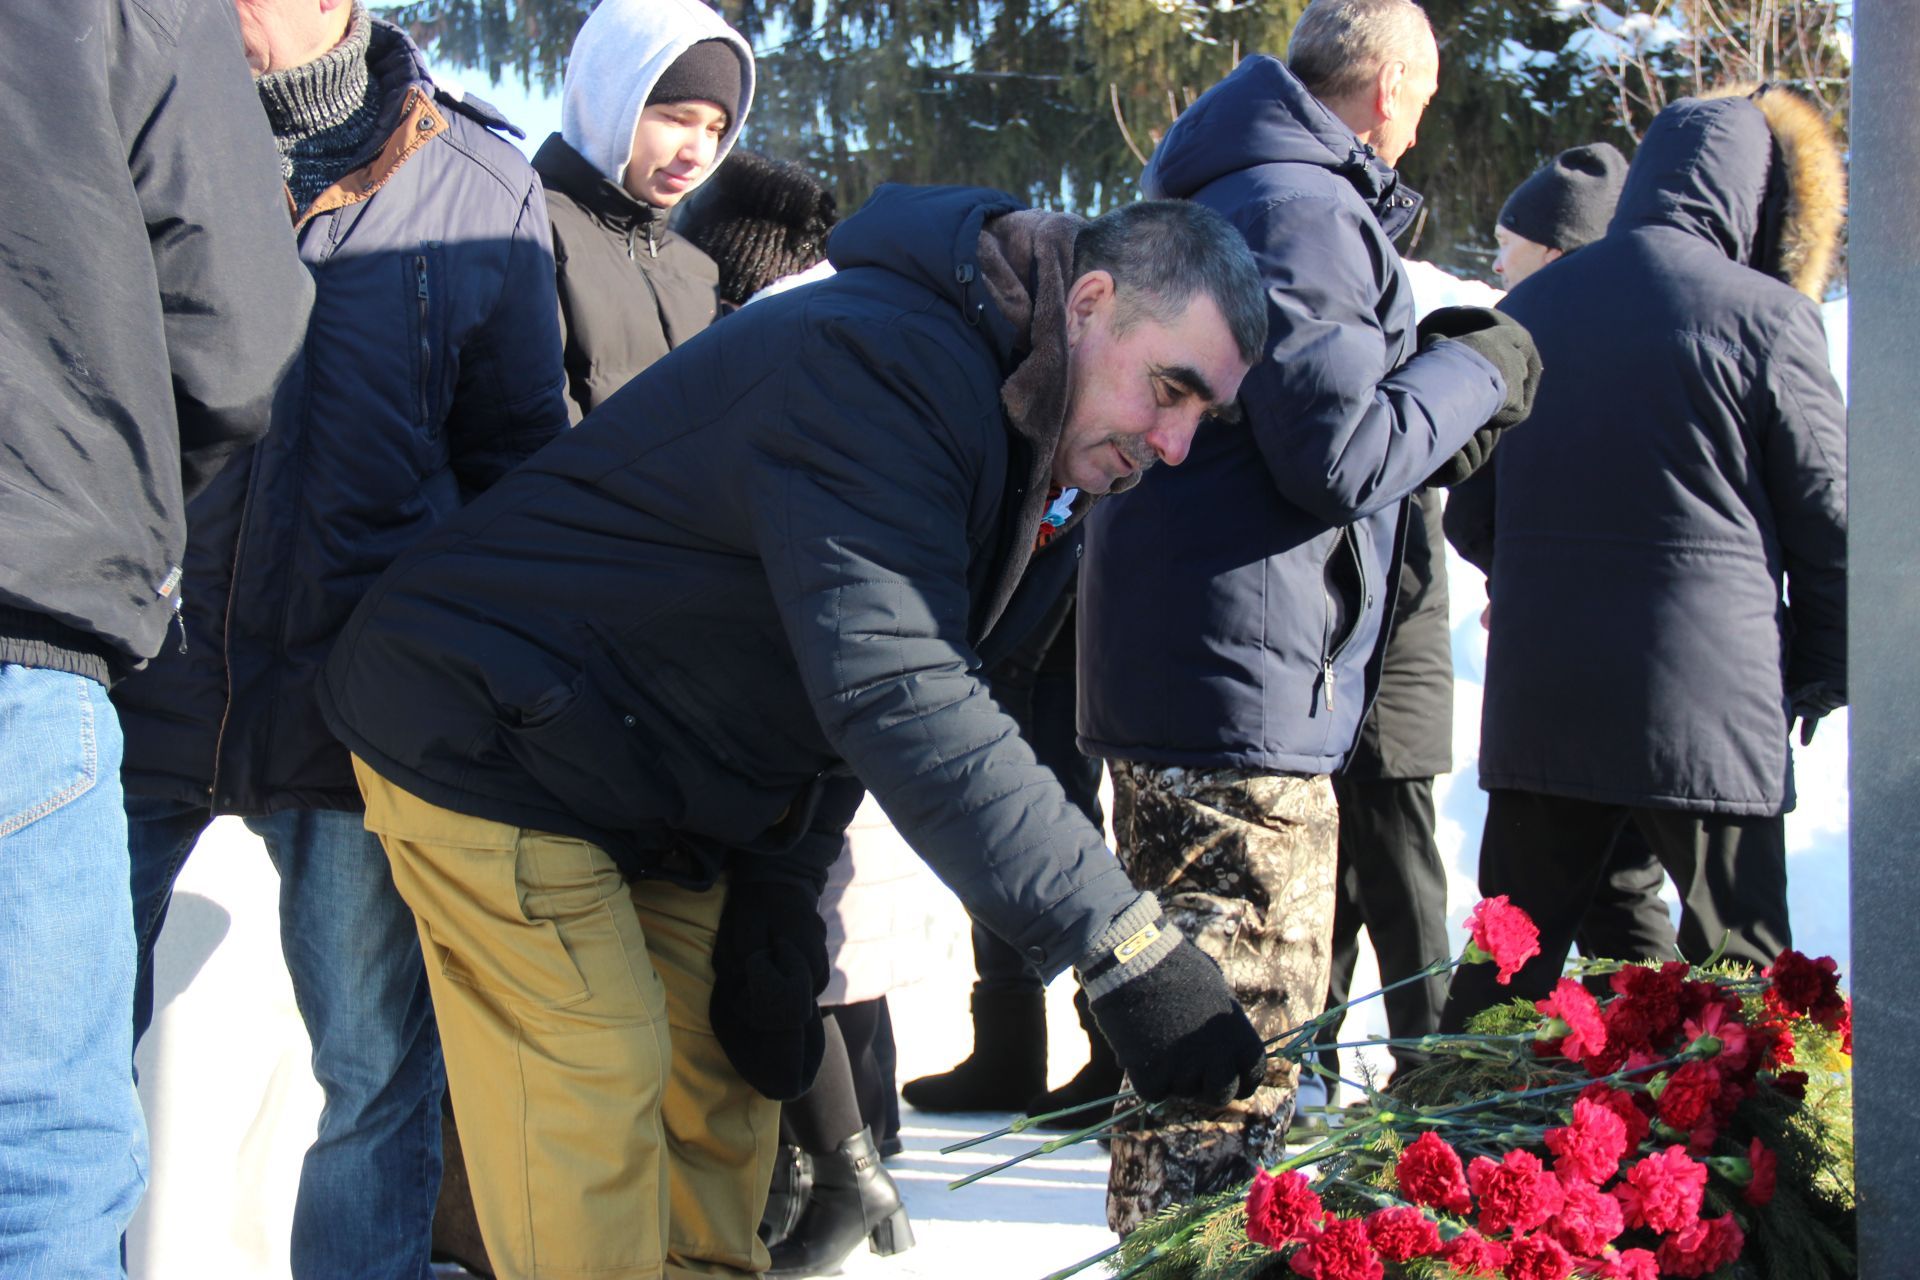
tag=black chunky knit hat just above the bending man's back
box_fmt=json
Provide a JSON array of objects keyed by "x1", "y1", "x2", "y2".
[{"x1": 680, "y1": 150, "x2": 839, "y2": 307}]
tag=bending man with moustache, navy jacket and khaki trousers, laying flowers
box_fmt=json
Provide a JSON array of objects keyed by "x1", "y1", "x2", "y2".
[{"x1": 323, "y1": 186, "x2": 1265, "y2": 1280}]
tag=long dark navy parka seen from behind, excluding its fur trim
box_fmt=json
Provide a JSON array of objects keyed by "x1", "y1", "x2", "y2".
[{"x1": 1448, "y1": 98, "x2": 1847, "y2": 816}]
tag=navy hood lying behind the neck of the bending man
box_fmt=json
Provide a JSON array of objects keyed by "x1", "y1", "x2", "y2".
[{"x1": 828, "y1": 182, "x2": 1025, "y2": 368}]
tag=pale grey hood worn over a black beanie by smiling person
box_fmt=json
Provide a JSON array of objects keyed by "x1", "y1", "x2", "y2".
[{"x1": 561, "y1": 0, "x2": 755, "y2": 186}]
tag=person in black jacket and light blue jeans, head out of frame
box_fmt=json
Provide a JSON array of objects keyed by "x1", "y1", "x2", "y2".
[{"x1": 0, "y1": 0, "x2": 313, "y2": 1280}]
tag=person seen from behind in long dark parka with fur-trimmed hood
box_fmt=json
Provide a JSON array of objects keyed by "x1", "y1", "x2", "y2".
[{"x1": 1444, "y1": 86, "x2": 1847, "y2": 1027}]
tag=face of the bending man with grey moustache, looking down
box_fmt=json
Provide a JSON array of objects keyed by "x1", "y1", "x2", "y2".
[{"x1": 1054, "y1": 271, "x2": 1246, "y2": 493}]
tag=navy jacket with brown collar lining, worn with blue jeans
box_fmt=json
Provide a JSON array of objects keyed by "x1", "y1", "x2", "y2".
[{"x1": 115, "y1": 21, "x2": 566, "y2": 814}]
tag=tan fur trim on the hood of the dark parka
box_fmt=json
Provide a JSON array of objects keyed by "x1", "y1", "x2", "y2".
[{"x1": 1703, "y1": 84, "x2": 1847, "y2": 301}]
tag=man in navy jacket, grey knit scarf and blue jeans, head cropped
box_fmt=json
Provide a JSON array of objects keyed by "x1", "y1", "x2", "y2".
[{"x1": 115, "y1": 0, "x2": 566, "y2": 1280}]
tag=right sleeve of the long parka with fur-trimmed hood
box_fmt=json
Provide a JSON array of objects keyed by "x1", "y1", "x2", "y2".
[{"x1": 1759, "y1": 301, "x2": 1847, "y2": 691}]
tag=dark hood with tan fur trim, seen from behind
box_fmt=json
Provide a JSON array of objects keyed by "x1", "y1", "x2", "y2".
[{"x1": 1609, "y1": 86, "x2": 1847, "y2": 301}]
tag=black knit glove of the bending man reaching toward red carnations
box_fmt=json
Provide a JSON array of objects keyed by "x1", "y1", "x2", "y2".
[{"x1": 1077, "y1": 894, "x2": 1267, "y2": 1107}]
